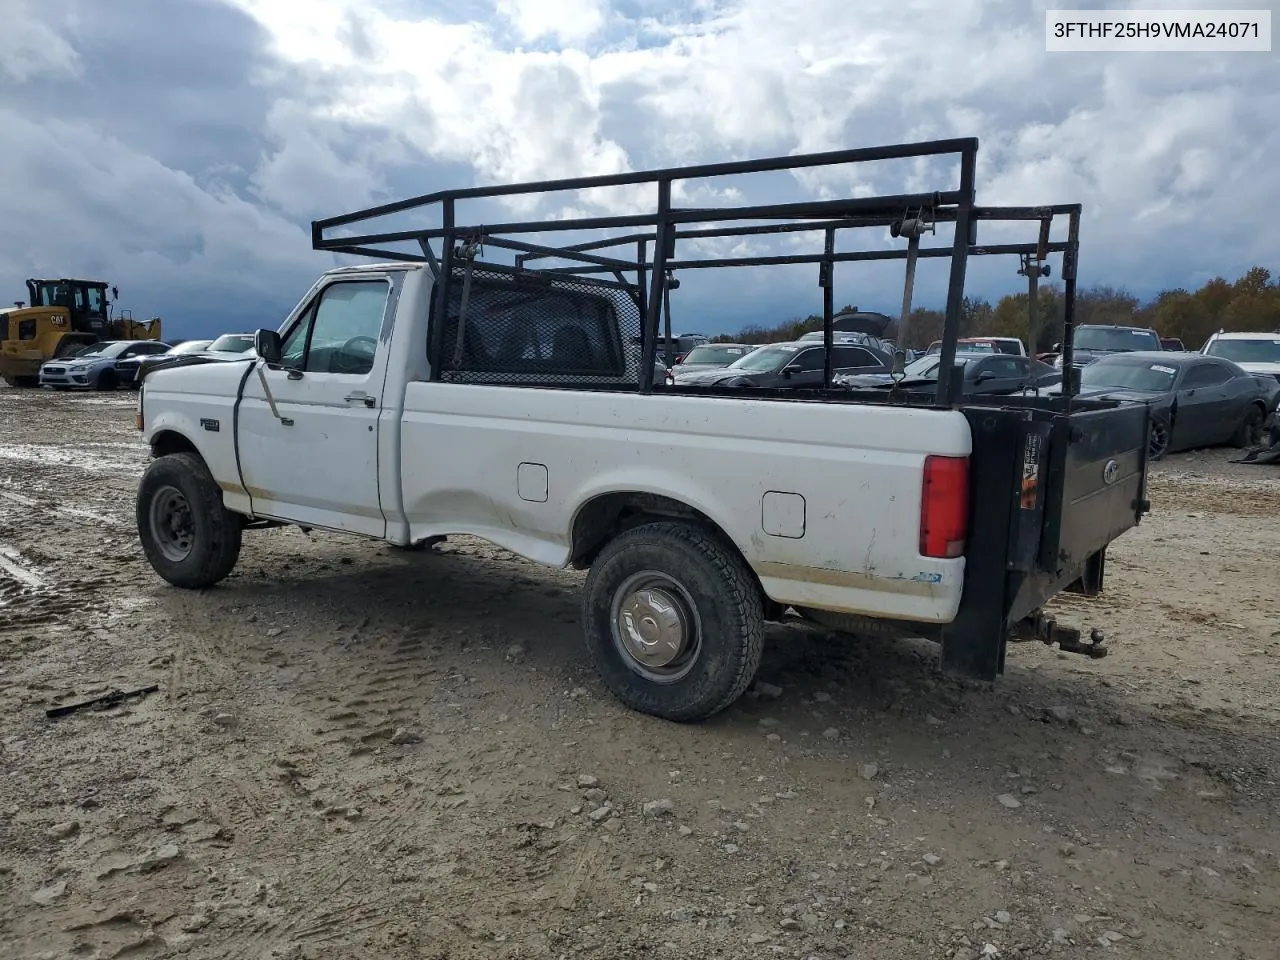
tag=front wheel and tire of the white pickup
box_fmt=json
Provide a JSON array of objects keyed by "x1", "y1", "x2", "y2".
[{"x1": 137, "y1": 453, "x2": 242, "y2": 590}]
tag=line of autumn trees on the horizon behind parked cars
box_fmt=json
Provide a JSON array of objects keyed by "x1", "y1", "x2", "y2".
[{"x1": 714, "y1": 266, "x2": 1280, "y2": 353}]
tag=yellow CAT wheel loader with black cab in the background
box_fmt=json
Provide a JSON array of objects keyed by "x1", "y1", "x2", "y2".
[{"x1": 0, "y1": 278, "x2": 160, "y2": 387}]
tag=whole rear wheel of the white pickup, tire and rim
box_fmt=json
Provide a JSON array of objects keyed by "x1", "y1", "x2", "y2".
[{"x1": 582, "y1": 521, "x2": 764, "y2": 723}]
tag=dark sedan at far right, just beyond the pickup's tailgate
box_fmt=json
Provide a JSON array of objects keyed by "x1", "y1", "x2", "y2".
[{"x1": 1079, "y1": 351, "x2": 1280, "y2": 460}]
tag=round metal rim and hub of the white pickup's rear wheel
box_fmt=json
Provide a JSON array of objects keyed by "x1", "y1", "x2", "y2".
[{"x1": 609, "y1": 570, "x2": 703, "y2": 684}]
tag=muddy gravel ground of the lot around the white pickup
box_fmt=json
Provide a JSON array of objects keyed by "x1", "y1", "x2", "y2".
[{"x1": 0, "y1": 389, "x2": 1280, "y2": 960}]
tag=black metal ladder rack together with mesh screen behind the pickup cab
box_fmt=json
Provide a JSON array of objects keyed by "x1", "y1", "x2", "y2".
[{"x1": 312, "y1": 138, "x2": 1080, "y2": 412}]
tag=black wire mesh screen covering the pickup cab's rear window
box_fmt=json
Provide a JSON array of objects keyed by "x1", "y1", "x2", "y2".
[{"x1": 431, "y1": 264, "x2": 644, "y2": 387}]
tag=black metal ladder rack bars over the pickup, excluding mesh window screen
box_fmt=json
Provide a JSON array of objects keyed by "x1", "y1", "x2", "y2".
[{"x1": 311, "y1": 137, "x2": 1082, "y2": 412}]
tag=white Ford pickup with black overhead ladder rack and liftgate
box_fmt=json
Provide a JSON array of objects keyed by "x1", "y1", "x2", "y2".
[{"x1": 129, "y1": 140, "x2": 1148, "y2": 721}]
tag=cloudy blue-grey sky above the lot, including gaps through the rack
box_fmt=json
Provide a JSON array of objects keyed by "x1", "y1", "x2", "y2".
[{"x1": 0, "y1": 0, "x2": 1280, "y2": 337}]
